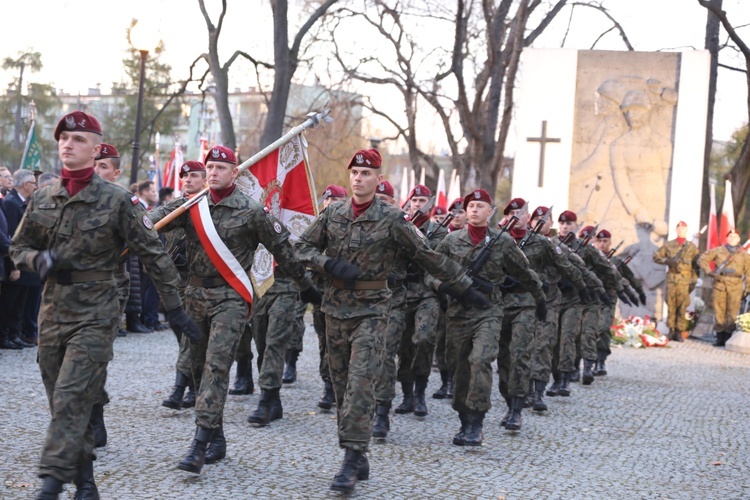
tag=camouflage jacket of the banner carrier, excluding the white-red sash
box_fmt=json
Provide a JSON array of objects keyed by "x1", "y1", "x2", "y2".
[{"x1": 149, "y1": 189, "x2": 312, "y2": 290}]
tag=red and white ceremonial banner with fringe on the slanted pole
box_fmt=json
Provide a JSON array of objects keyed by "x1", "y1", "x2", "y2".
[{"x1": 237, "y1": 135, "x2": 318, "y2": 296}]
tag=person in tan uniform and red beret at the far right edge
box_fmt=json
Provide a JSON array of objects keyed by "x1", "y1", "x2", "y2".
[{"x1": 698, "y1": 229, "x2": 750, "y2": 347}]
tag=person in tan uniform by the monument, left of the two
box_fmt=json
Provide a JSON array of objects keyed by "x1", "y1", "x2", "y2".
[{"x1": 653, "y1": 221, "x2": 698, "y2": 342}]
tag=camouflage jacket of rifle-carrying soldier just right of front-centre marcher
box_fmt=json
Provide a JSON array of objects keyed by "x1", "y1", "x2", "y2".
[{"x1": 428, "y1": 228, "x2": 545, "y2": 318}]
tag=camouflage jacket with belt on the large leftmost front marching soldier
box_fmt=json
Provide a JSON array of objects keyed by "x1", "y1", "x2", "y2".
[{"x1": 10, "y1": 175, "x2": 182, "y2": 323}]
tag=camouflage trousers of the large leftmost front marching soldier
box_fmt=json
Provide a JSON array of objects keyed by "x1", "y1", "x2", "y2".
[{"x1": 38, "y1": 318, "x2": 119, "y2": 483}]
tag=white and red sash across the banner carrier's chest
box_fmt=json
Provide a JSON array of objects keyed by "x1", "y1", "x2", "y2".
[{"x1": 190, "y1": 195, "x2": 253, "y2": 306}]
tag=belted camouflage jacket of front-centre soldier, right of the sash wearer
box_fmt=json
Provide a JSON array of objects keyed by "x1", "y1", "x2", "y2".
[{"x1": 297, "y1": 197, "x2": 471, "y2": 319}]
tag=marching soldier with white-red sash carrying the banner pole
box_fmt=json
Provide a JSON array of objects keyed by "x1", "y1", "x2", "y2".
[{"x1": 151, "y1": 146, "x2": 319, "y2": 474}]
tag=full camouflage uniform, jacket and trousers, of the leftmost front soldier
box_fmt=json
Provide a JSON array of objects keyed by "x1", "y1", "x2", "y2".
[{"x1": 10, "y1": 175, "x2": 181, "y2": 482}]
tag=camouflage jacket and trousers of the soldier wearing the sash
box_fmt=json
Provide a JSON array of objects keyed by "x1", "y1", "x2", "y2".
[{"x1": 150, "y1": 188, "x2": 312, "y2": 429}]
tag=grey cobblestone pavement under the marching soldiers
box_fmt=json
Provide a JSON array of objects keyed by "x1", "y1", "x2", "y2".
[{"x1": 0, "y1": 315, "x2": 750, "y2": 499}]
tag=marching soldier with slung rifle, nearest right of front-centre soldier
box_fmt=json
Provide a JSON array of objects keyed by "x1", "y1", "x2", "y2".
[{"x1": 428, "y1": 189, "x2": 547, "y2": 446}]
